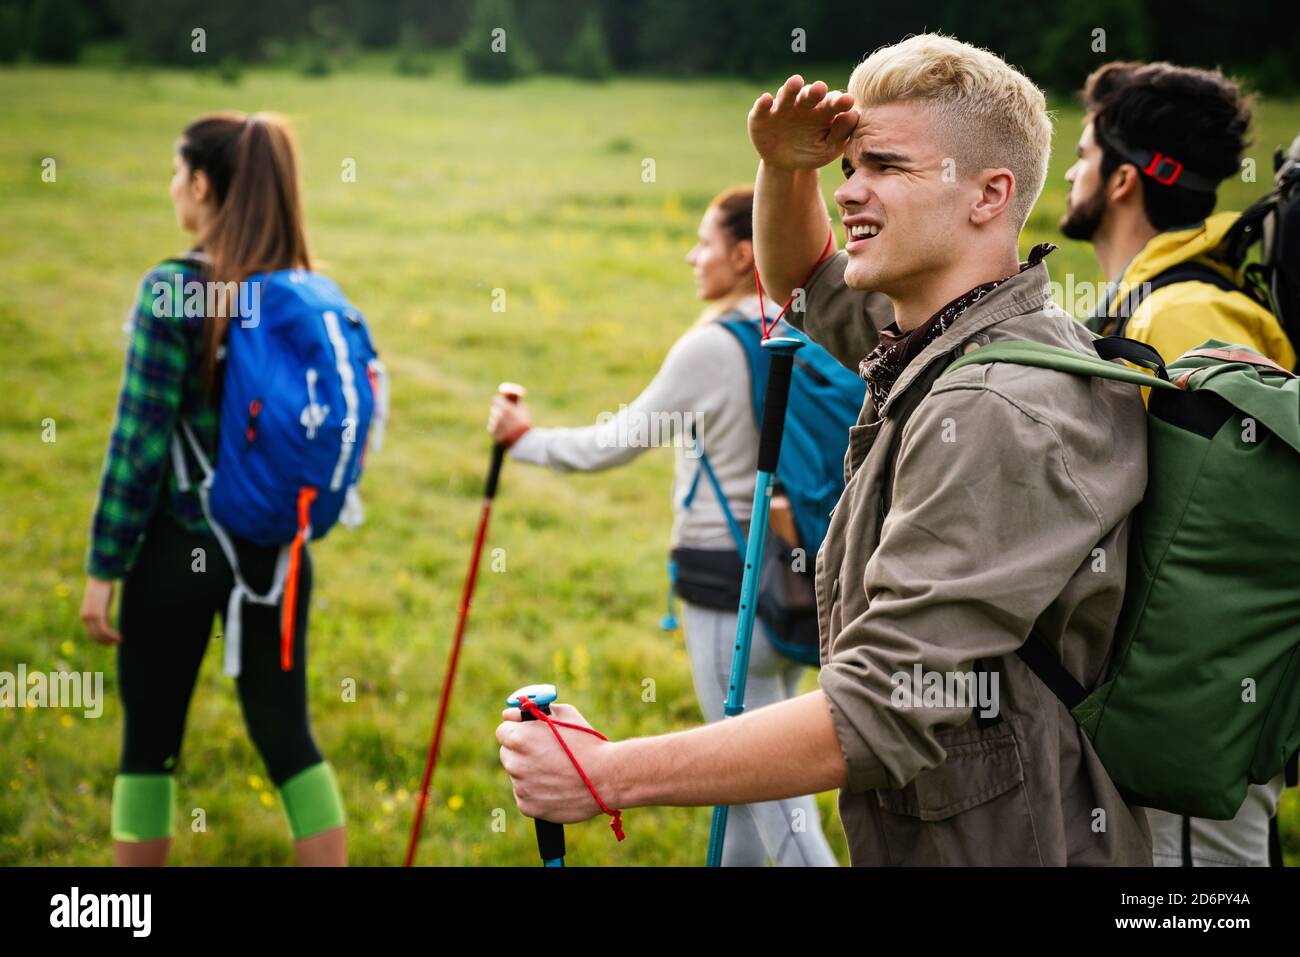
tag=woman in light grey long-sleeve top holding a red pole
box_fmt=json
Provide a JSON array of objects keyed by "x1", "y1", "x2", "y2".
[{"x1": 488, "y1": 186, "x2": 836, "y2": 866}]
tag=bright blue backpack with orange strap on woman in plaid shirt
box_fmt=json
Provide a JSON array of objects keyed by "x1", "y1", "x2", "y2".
[{"x1": 172, "y1": 269, "x2": 387, "y2": 676}]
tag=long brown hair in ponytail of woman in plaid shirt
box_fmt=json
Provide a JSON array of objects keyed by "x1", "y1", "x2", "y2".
[{"x1": 178, "y1": 113, "x2": 312, "y2": 395}]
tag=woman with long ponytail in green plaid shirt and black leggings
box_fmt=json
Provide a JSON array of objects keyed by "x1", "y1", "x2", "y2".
[{"x1": 82, "y1": 113, "x2": 346, "y2": 865}]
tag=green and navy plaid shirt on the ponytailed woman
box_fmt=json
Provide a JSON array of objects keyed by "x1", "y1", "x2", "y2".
[{"x1": 86, "y1": 261, "x2": 218, "y2": 579}]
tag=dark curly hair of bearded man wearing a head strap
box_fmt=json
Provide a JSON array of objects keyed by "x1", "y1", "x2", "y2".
[{"x1": 1080, "y1": 62, "x2": 1255, "y2": 229}]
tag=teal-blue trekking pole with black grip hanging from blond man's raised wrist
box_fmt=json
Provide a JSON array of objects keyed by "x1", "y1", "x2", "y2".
[{"x1": 709, "y1": 337, "x2": 803, "y2": 867}]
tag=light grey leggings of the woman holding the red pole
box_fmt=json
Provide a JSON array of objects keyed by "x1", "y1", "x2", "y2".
[{"x1": 681, "y1": 602, "x2": 836, "y2": 867}]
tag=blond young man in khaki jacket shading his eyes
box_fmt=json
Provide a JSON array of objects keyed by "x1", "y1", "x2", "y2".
[{"x1": 497, "y1": 35, "x2": 1151, "y2": 865}]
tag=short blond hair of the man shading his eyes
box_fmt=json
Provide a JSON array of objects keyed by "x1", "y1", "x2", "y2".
[{"x1": 848, "y1": 34, "x2": 1052, "y2": 231}]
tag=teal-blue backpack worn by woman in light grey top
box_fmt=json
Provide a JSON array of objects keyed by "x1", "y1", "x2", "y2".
[{"x1": 663, "y1": 312, "x2": 867, "y2": 666}]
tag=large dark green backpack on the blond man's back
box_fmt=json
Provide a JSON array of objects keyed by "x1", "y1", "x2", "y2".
[{"x1": 945, "y1": 337, "x2": 1300, "y2": 820}]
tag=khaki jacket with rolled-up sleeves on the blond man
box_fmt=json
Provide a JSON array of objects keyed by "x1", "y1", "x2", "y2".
[{"x1": 793, "y1": 252, "x2": 1152, "y2": 865}]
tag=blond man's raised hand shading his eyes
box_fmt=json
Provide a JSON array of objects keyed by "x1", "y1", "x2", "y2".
[{"x1": 749, "y1": 74, "x2": 858, "y2": 169}]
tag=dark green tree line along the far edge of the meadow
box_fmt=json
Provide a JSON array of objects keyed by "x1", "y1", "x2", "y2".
[{"x1": 0, "y1": 0, "x2": 1300, "y2": 95}]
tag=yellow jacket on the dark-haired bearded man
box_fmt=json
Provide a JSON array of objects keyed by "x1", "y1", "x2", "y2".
[{"x1": 1102, "y1": 213, "x2": 1296, "y2": 369}]
